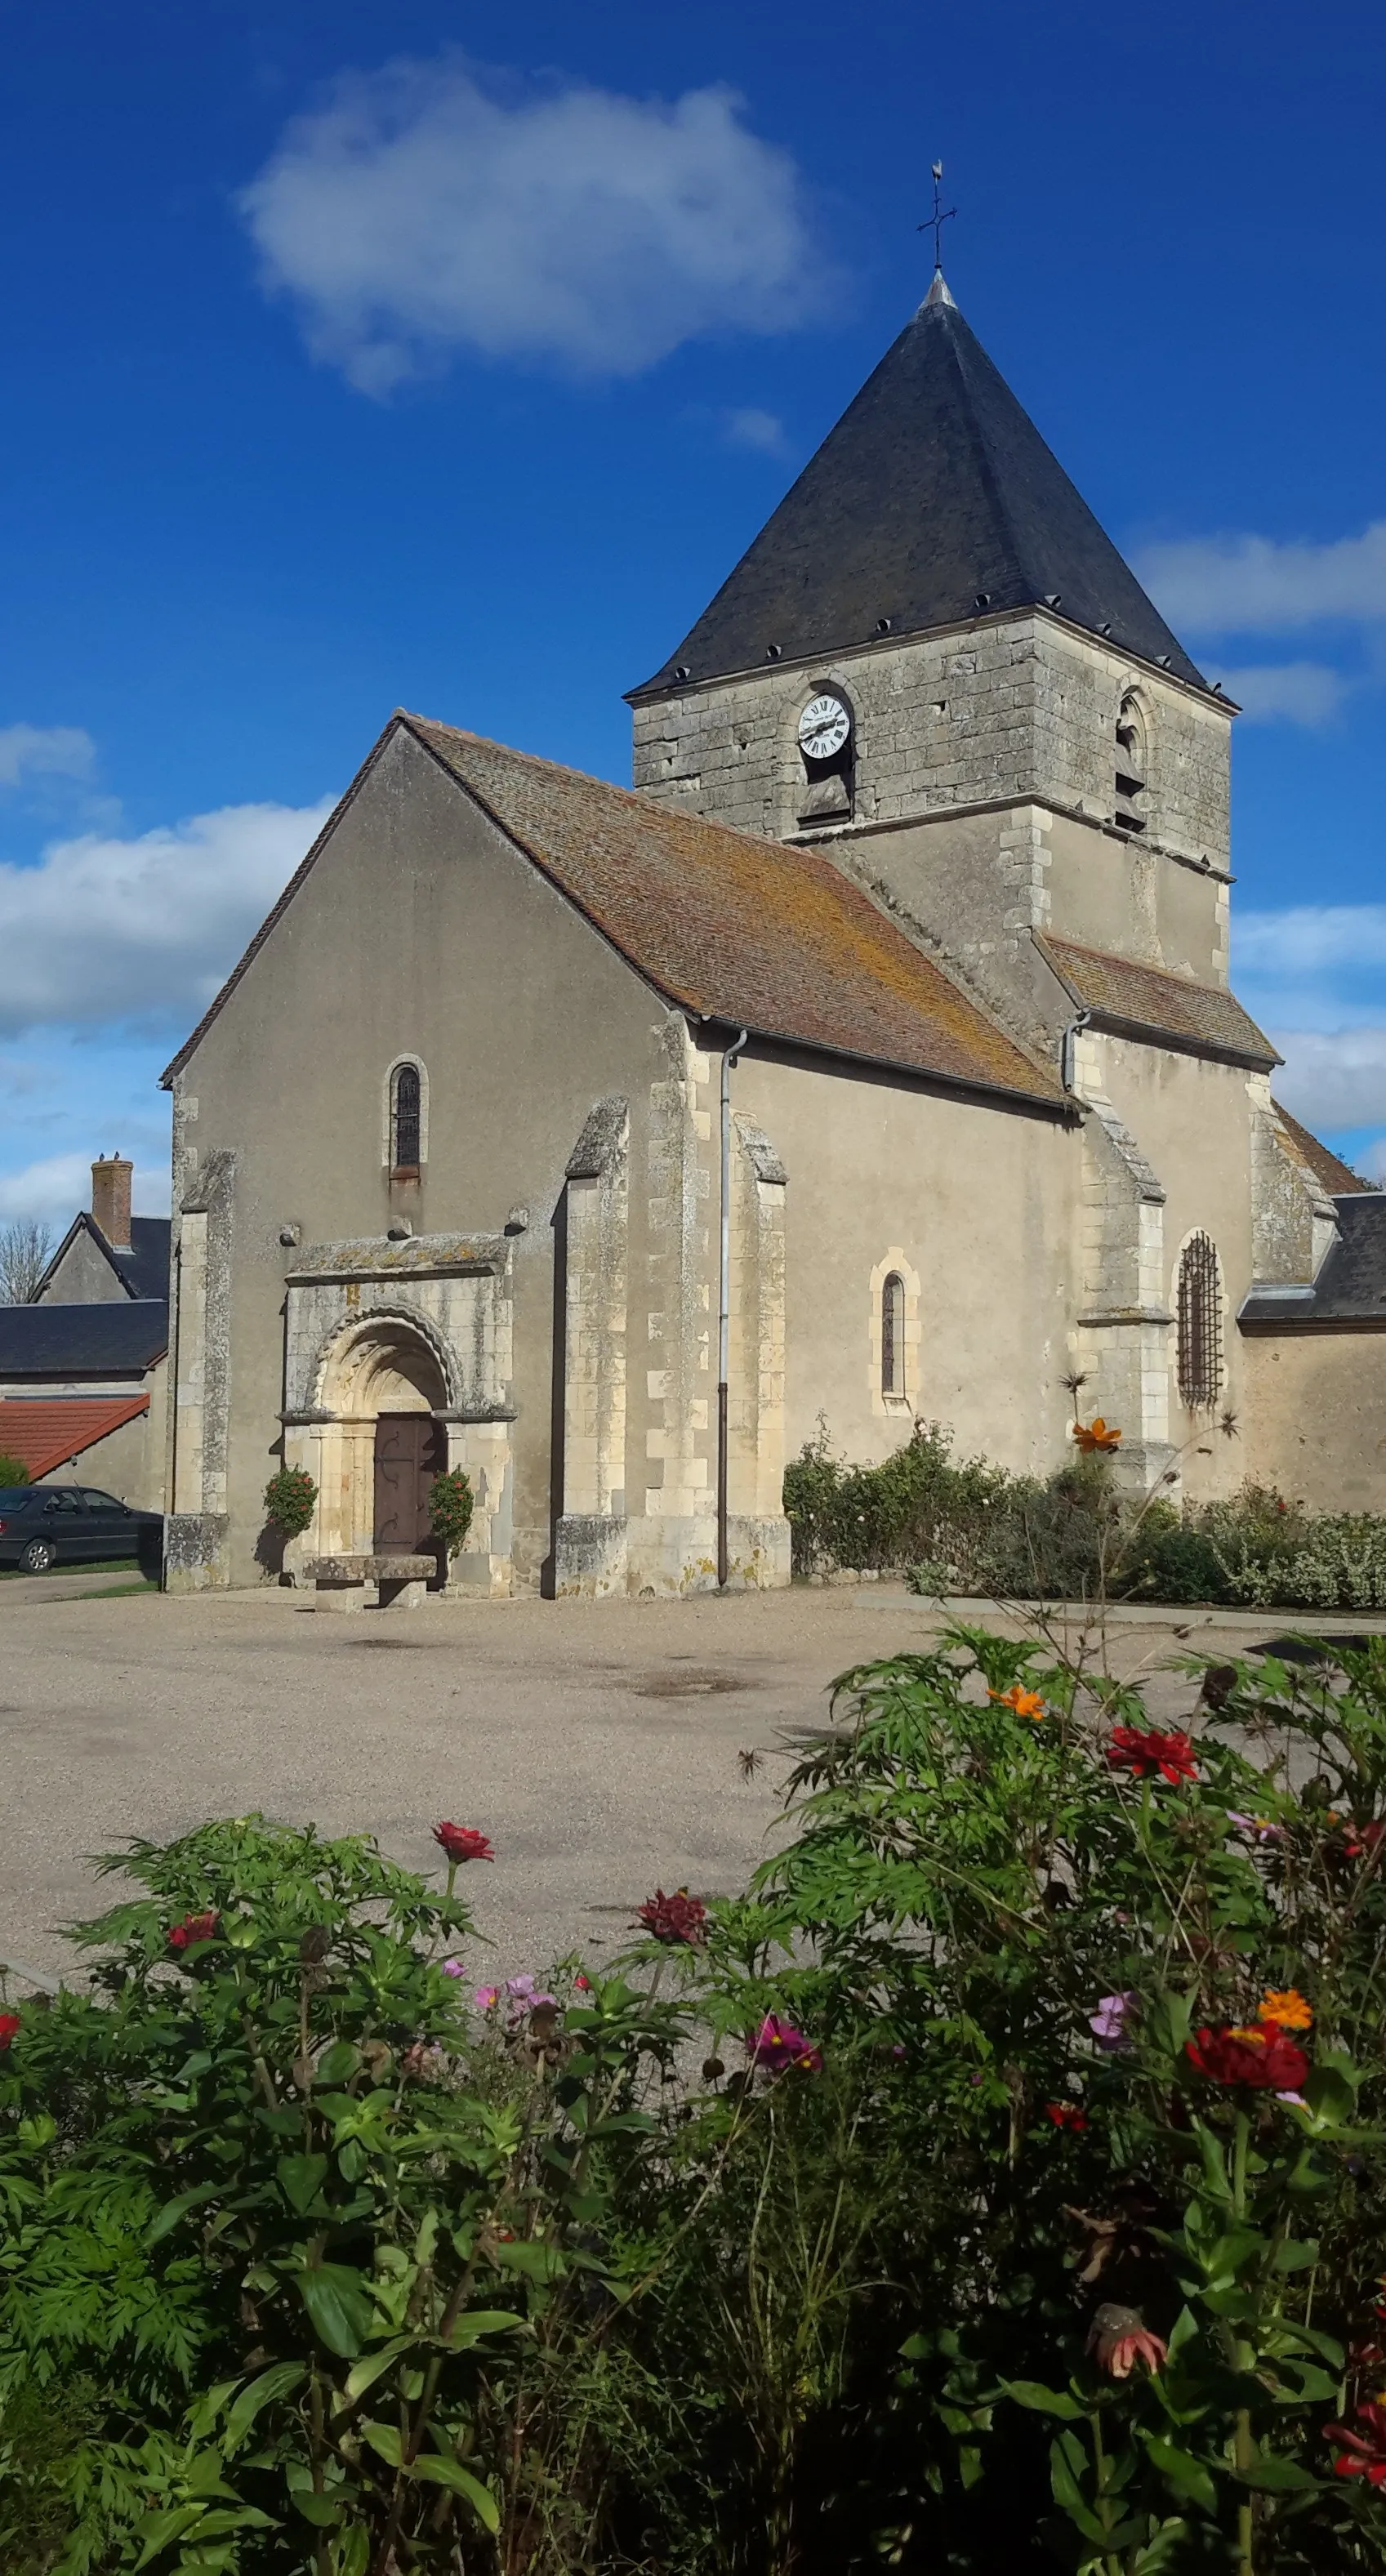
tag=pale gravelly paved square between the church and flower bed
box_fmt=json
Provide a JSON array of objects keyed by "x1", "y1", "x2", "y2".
[{"x1": 0, "y1": 1579, "x2": 1363, "y2": 1976}]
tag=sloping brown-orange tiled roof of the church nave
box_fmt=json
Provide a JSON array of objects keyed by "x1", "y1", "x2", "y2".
[{"x1": 404, "y1": 716, "x2": 1064, "y2": 1108}]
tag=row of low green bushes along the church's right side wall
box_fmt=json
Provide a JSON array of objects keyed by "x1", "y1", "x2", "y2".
[{"x1": 783, "y1": 1422, "x2": 1386, "y2": 1610}]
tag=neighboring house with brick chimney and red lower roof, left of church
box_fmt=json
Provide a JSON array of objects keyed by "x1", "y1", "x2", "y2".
[{"x1": 0, "y1": 1157, "x2": 170, "y2": 1512}]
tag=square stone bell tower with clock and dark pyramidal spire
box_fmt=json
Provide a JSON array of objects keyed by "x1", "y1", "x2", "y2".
[{"x1": 631, "y1": 270, "x2": 1234, "y2": 1049}]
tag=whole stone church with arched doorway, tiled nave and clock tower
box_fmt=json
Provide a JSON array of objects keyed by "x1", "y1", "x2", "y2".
[{"x1": 165, "y1": 261, "x2": 1386, "y2": 1594}]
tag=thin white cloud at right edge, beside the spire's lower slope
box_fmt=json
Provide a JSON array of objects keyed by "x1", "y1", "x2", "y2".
[{"x1": 1136, "y1": 520, "x2": 1386, "y2": 639}]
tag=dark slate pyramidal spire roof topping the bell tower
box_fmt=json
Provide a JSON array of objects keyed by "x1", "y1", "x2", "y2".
[{"x1": 631, "y1": 281, "x2": 1208, "y2": 698}]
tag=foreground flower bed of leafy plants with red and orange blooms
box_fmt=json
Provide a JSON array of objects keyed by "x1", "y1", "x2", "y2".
[{"x1": 0, "y1": 1628, "x2": 1386, "y2": 2576}]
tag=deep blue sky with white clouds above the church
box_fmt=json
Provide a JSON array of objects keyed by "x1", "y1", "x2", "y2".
[{"x1": 0, "y1": 0, "x2": 1386, "y2": 1223}]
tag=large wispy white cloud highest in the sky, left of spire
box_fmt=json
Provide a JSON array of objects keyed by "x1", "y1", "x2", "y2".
[{"x1": 239, "y1": 51, "x2": 824, "y2": 394}]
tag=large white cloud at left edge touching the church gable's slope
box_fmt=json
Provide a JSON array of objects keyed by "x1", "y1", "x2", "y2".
[{"x1": 0, "y1": 801, "x2": 330, "y2": 1033}]
